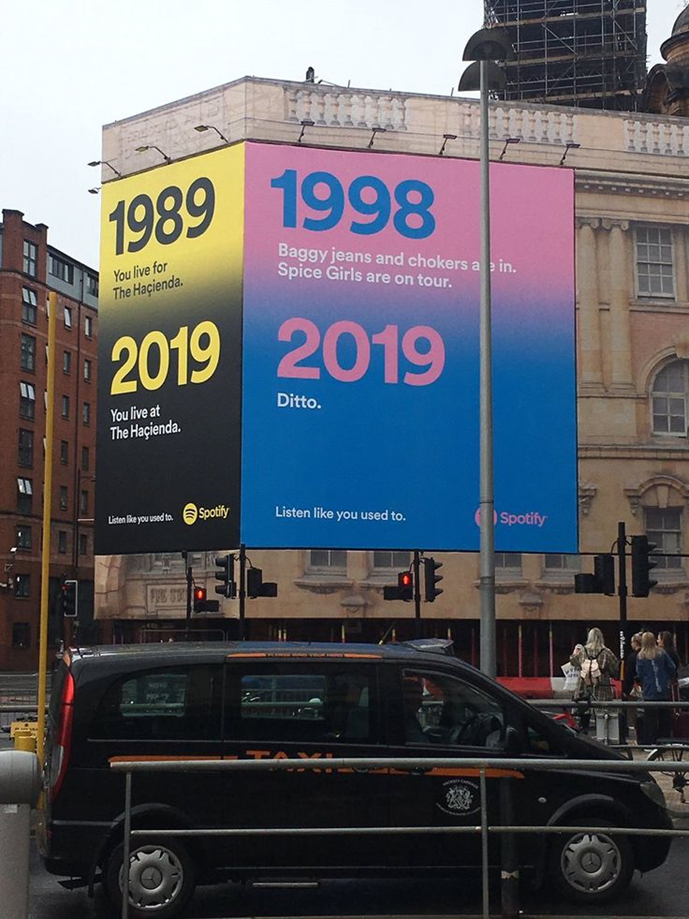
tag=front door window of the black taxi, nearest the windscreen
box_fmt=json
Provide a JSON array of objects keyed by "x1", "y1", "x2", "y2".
[{"x1": 402, "y1": 669, "x2": 506, "y2": 750}]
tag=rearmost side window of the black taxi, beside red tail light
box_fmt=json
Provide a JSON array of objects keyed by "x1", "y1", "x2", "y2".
[{"x1": 89, "y1": 665, "x2": 222, "y2": 740}]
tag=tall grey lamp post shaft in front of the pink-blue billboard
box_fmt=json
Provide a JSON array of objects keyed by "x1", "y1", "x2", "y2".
[{"x1": 479, "y1": 61, "x2": 497, "y2": 679}]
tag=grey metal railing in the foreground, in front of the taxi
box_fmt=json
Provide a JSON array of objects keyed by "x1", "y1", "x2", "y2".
[{"x1": 110, "y1": 757, "x2": 689, "y2": 919}]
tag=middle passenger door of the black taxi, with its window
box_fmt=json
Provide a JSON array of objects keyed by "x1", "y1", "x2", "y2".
[{"x1": 215, "y1": 654, "x2": 387, "y2": 875}]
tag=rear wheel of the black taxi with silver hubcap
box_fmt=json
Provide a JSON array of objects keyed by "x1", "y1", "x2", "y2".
[{"x1": 103, "y1": 839, "x2": 196, "y2": 919}]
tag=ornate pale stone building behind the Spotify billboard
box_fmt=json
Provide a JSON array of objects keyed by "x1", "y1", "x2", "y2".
[{"x1": 96, "y1": 13, "x2": 689, "y2": 677}]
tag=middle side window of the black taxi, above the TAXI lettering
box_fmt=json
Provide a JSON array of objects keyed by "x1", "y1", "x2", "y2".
[{"x1": 225, "y1": 664, "x2": 377, "y2": 744}]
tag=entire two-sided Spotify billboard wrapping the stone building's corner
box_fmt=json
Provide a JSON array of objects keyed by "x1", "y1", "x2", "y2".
[{"x1": 96, "y1": 143, "x2": 577, "y2": 553}]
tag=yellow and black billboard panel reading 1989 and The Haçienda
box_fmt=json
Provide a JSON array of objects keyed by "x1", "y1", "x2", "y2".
[{"x1": 95, "y1": 147, "x2": 244, "y2": 554}]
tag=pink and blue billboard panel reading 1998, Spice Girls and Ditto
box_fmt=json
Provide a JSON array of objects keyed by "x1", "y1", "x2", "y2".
[{"x1": 241, "y1": 144, "x2": 578, "y2": 552}]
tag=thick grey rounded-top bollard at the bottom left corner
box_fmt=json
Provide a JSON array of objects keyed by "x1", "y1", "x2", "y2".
[{"x1": 0, "y1": 750, "x2": 42, "y2": 919}]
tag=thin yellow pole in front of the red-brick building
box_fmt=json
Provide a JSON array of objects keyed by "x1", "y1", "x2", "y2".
[{"x1": 36, "y1": 293, "x2": 57, "y2": 765}]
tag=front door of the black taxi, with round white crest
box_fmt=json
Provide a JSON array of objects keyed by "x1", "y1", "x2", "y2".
[{"x1": 386, "y1": 666, "x2": 522, "y2": 869}]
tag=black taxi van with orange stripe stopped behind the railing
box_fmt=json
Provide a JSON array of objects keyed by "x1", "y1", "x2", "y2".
[{"x1": 40, "y1": 640, "x2": 671, "y2": 919}]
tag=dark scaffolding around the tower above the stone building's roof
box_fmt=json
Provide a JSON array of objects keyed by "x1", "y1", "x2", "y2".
[{"x1": 484, "y1": 0, "x2": 646, "y2": 111}]
